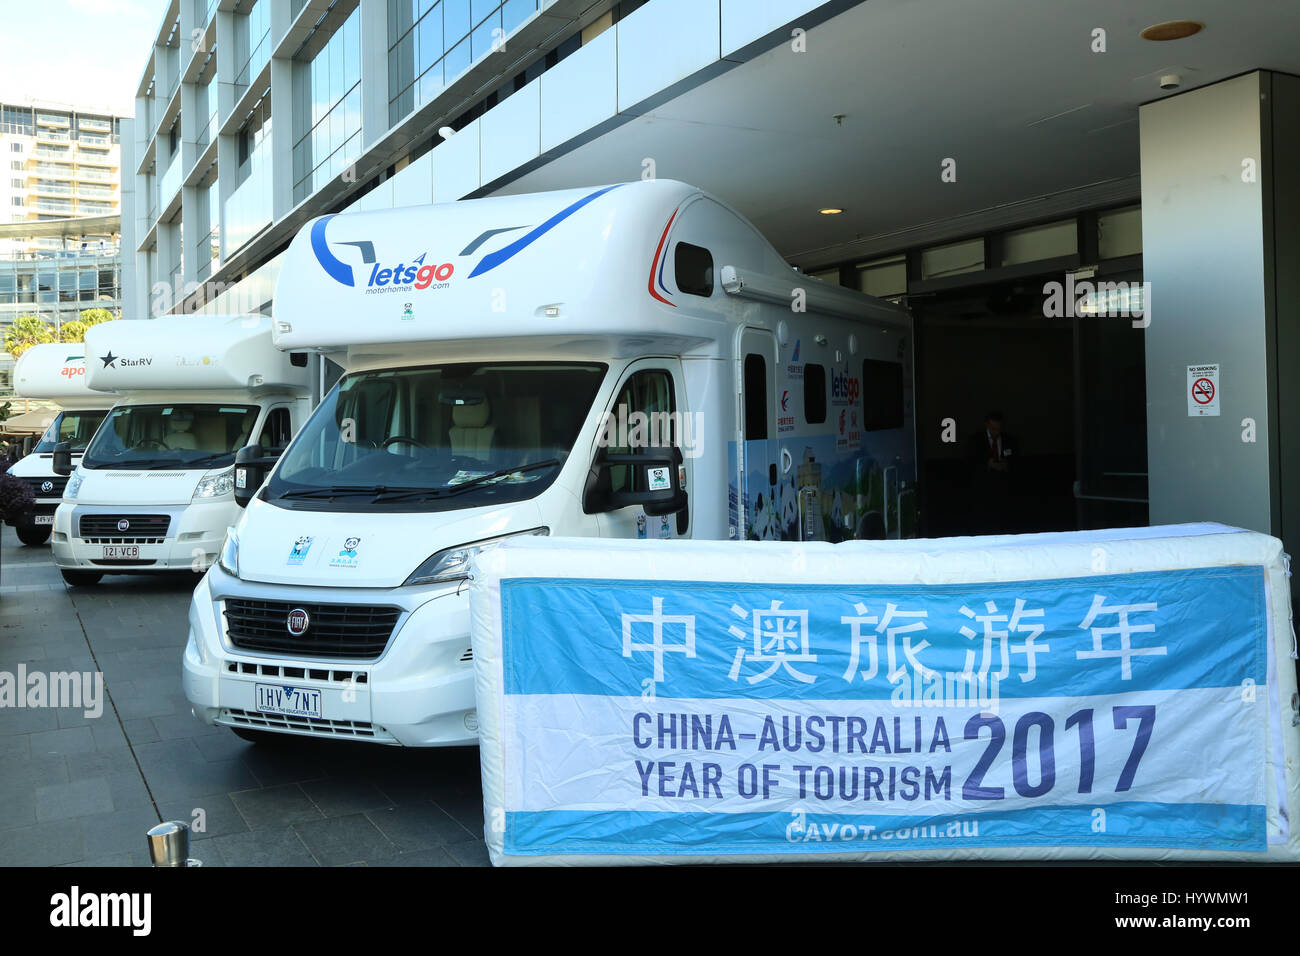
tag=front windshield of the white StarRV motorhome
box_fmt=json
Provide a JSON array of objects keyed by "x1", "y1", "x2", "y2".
[{"x1": 82, "y1": 403, "x2": 257, "y2": 468}]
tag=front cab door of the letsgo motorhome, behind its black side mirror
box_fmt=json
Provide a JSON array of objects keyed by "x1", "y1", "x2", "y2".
[{"x1": 598, "y1": 359, "x2": 696, "y2": 538}]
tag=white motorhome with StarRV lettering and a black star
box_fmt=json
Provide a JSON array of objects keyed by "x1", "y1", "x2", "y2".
[{"x1": 51, "y1": 315, "x2": 311, "y2": 585}]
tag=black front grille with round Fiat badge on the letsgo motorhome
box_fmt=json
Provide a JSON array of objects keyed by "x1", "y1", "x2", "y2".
[{"x1": 226, "y1": 598, "x2": 402, "y2": 659}]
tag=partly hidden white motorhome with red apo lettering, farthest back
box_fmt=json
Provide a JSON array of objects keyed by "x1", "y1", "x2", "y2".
[{"x1": 9, "y1": 343, "x2": 116, "y2": 545}]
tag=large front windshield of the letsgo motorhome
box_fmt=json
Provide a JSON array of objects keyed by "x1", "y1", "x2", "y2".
[{"x1": 274, "y1": 362, "x2": 606, "y2": 510}]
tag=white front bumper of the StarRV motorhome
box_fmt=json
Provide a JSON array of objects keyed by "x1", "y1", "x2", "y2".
[{"x1": 49, "y1": 499, "x2": 239, "y2": 574}]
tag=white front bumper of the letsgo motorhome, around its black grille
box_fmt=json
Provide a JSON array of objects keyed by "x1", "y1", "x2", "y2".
[{"x1": 183, "y1": 567, "x2": 478, "y2": 747}]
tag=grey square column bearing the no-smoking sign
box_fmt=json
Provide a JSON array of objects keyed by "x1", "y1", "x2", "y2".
[{"x1": 1138, "y1": 72, "x2": 1300, "y2": 549}]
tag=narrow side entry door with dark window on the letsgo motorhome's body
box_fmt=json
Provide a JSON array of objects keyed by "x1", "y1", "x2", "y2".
[{"x1": 736, "y1": 328, "x2": 780, "y2": 541}]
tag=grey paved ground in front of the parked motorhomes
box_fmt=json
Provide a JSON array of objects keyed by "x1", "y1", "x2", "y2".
[{"x1": 0, "y1": 528, "x2": 488, "y2": 866}]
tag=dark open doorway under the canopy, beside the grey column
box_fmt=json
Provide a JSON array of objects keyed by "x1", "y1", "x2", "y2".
[{"x1": 909, "y1": 276, "x2": 1147, "y2": 537}]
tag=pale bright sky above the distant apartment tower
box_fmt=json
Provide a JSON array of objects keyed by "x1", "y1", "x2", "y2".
[{"x1": 0, "y1": 0, "x2": 168, "y2": 116}]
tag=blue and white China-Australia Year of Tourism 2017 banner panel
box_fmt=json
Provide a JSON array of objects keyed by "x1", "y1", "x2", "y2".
[{"x1": 476, "y1": 566, "x2": 1273, "y2": 857}]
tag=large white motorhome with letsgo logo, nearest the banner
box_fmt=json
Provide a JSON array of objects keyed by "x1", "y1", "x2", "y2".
[{"x1": 183, "y1": 181, "x2": 915, "y2": 747}]
